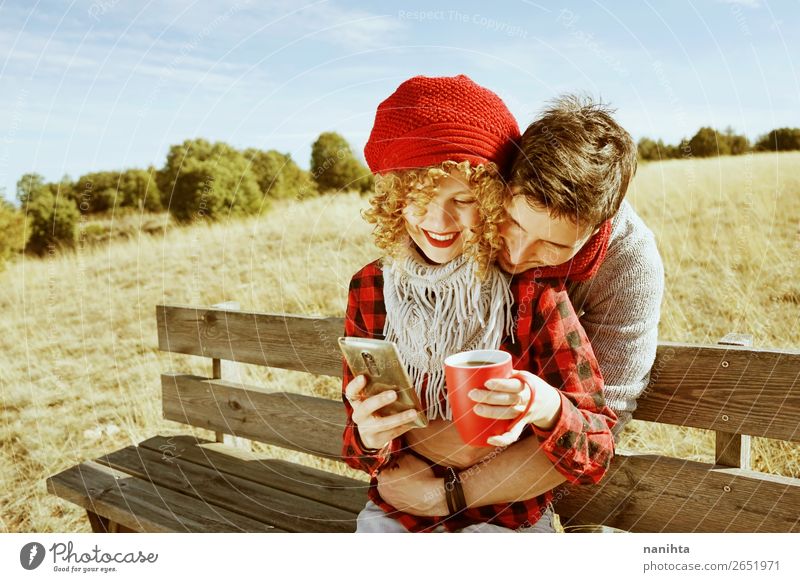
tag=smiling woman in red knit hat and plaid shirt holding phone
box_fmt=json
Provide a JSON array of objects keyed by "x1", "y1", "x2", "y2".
[{"x1": 343, "y1": 76, "x2": 616, "y2": 531}]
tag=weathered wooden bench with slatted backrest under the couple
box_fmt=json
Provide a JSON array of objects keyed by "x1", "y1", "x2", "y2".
[{"x1": 47, "y1": 305, "x2": 800, "y2": 532}]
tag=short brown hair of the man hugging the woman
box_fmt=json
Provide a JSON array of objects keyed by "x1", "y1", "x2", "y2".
[{"x1": 510, "y1": 95, "x2": 637, "y2": 227}]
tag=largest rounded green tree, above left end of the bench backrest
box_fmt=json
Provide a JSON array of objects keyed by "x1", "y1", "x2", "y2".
[{"x1": 156, "y1": 139, "x2": 265, "y2": 222}]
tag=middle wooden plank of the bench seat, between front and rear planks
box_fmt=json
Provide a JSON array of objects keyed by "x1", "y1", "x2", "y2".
[{"x1": 97, "y1": 447, "x2": 356, "y2": 532}]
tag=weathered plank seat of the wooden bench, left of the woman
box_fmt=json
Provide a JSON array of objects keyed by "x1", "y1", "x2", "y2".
[{"x1": 47, "y1": 435, "x2": 367, "y2": 532}]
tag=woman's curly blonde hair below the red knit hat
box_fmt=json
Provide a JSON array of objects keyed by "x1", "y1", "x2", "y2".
[{"x1": 363, "y1": 161, "x2": 506, "y2": 278}]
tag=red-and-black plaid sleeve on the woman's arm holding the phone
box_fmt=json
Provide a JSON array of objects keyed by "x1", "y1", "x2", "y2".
[{"x1": 342, "y1": 263, "x2": 402, "y2": 477}]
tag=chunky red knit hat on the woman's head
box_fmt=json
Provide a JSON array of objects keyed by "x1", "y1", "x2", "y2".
[{"x1": 364, "y1": 75, "x2": 520, "y2": 174}]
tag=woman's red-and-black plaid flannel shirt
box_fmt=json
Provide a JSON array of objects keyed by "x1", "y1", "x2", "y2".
[{"x1": 342, "y1": 261, "x2": 617, "y2": 532}]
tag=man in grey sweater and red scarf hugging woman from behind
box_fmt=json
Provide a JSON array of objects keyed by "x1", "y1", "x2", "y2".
[{"x1": 378, "y1": 96, "x2": 664, "y2": 513}]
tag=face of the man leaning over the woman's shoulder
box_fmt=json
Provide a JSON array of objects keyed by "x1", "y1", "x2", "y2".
[{"x1": 497, "y1": 195, "x2": 597, "y2": 274}]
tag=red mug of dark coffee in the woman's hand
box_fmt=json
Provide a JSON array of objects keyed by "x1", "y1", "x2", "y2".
[{"x1": 444, "y1": 350, "x2": 534, "y2": 447}]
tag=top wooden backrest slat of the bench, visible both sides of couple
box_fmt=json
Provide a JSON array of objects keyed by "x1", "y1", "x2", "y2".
[{"x1": 156, "y1": 305, "x2": 800, "y2": 441}]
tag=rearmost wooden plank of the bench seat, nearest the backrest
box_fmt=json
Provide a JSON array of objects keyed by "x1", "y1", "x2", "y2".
[{"x1": 139, "y1": 435, "x2": 369, "y2": 513}]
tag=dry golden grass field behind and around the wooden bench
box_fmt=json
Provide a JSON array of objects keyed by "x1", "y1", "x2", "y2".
[{"x1": 0, "y1": 153, "x2": 800, "y2": 532}]
